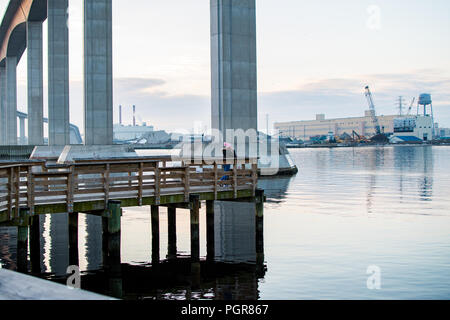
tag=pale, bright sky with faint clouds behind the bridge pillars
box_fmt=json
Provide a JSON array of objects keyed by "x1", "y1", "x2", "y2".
[{"x1": 0, "y1": 0, "x2": 450, "y2": 135}]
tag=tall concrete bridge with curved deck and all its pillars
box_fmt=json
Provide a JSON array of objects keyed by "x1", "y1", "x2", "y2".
[{"x1": 0, "y1": 0, "x2": 257, "y2": 149}]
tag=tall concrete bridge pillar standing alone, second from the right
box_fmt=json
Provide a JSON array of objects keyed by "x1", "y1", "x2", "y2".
[{"x1": 84, "y1": 0, "x2": 113, "y2": 145}]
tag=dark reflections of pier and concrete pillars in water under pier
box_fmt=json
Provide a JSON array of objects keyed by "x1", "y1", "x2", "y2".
[{"x1": 0, "y1": 201, "x2": 266, "y2": 300}]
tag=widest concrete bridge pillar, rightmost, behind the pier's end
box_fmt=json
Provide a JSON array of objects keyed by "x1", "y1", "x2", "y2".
[{"x1": 210, "y1": 0, "x2": 257, "y2": 142}]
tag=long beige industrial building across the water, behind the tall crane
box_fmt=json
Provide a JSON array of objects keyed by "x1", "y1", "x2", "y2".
[{"x1": 275, "y1": 110, "x2": 399, "y2": 140}]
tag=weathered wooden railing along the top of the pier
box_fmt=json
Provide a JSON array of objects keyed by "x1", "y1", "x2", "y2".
[{"x1": 0, "y1": 158, "x2": 258, "y2": 222}]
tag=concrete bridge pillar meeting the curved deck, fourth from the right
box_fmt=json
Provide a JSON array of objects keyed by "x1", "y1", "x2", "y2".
[{"x1": 27, "y1": 21, "x2": 44, "y2": 145}]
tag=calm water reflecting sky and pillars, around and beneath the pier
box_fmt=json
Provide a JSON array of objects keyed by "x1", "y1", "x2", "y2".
[{"x1": 0, "y1": 146, "x2": 450, "y2": 299}]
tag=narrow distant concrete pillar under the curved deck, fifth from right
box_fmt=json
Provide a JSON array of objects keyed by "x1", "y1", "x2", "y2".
[{"x1": 6, "y1": 57, "x2": 17, "y2": 145}]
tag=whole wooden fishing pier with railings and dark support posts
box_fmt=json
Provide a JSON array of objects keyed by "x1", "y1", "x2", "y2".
[{"x1": 0, "y1": 157, "x2": 264, "y2": 280}]
